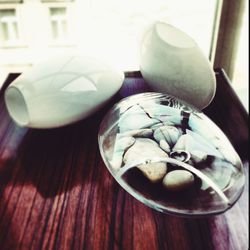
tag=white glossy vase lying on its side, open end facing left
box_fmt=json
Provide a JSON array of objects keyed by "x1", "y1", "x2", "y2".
[{"x1": 5, "y1": 55, "x2": 124, "y2": 128}]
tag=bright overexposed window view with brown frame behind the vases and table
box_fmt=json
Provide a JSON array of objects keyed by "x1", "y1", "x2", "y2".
[{"x1": 0, "y1": 0, "x2": 249, "y2": 110}]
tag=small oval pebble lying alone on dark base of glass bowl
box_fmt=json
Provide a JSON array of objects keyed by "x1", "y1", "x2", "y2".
[{"x1": 162, "y1": 170, "x2": 194, "y2": 191}]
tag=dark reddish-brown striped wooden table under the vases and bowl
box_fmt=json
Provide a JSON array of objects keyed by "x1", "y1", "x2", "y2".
[{"x1": 0, "y1": 69, "x2": 249, "y2": 250}]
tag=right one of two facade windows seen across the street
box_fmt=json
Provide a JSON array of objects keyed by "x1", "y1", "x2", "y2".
[{"x1": 50, "y1": 7, "x2": 68, "y2": 42}]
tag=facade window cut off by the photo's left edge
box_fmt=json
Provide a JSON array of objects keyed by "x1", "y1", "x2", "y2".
[{"x1": 0, "y1": 9, "x2": 19, "y2": 45}]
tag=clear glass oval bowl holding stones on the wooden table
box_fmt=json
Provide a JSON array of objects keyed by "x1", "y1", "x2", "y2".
[{"x1": 98, "y1": 92, "x2": 245, "y2": 216}]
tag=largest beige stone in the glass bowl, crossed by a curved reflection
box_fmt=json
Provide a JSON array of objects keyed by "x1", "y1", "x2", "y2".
[{"x1": 123, "y1": 138, "x2": 168, "y2": 182}]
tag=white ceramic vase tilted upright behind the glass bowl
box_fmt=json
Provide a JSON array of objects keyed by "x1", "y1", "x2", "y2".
[{"x1": 140, "y1": 22, "x2": 216, "y2": 109}]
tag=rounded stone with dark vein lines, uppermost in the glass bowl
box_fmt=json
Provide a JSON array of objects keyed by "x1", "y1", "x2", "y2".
[{"x1": 154, "y1": 126, "x2": 181, "y2": 147}]
